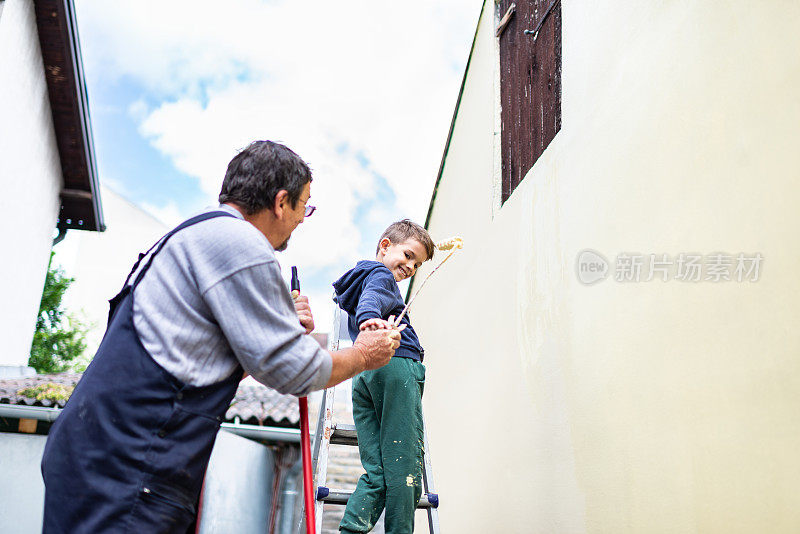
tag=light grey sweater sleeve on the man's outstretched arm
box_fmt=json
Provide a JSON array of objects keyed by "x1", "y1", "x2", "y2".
[{"x1": 203, "y1": 262, "x2": 332, "y2": 396}]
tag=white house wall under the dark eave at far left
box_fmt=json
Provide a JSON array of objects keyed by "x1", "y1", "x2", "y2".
[{"x1": 0, "y1": 0, "x2": 62, "y2": 366}]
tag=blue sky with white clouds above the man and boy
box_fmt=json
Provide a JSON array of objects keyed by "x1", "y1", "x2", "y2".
[{"x1": 69, "y1": 0, "x2": 481, "y2": 331}]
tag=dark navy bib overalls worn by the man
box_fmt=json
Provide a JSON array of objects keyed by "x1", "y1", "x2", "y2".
[{"x1": 42, "y1": 211, "x2": 242, "y2": 534}]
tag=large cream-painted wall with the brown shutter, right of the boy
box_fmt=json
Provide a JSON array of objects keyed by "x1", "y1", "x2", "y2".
[{"x1": 413, "y1": 0, "x2": 800, "y2": 534}]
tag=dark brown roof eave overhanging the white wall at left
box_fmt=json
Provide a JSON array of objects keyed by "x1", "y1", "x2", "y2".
[{"x1": 34, "y1": 0, "x2": 105, "y2": 231}]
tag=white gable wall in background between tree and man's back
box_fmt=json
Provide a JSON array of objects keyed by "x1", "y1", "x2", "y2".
[{"x1": 55, "y1": 186, "x2": 171, "y2": 355}]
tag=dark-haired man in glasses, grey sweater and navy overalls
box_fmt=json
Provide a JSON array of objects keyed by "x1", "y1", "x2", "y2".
[{"x1": 42, "y1": 141, "x2": 400, "y2": 533}]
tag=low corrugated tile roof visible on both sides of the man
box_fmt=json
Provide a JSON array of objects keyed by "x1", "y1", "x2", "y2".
[{"x1": 0, "y1": 373, "x2": 300, "y2": 428}]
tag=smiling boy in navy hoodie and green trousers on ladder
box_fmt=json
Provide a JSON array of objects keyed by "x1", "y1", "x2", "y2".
[{"x1": 333, "y1": 219, "x2": 434, "y2": 534}]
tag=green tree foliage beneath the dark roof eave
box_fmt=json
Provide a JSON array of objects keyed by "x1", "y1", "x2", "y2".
[{"x1": 28, "y1": 252, "x2": 86, "y2": 373}]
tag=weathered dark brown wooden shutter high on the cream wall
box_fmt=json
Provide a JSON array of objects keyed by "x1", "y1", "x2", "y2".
[{"x1": 500, "y1": 0, "x2": 561, "y2": 202}]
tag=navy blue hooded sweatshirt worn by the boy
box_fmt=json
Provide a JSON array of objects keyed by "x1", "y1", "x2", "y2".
[{"x1": 333, "y1": 260, "x2": 425, "y2": 362}]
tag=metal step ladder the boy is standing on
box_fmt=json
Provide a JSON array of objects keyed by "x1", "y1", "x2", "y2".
[{"x1": 304, "y1": 306, "x2": 440, "y2": 534}]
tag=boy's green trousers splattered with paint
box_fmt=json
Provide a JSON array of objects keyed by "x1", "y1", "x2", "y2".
[{"x1": 339, "y1": 357, "x2": 425, "y2": 534}]
